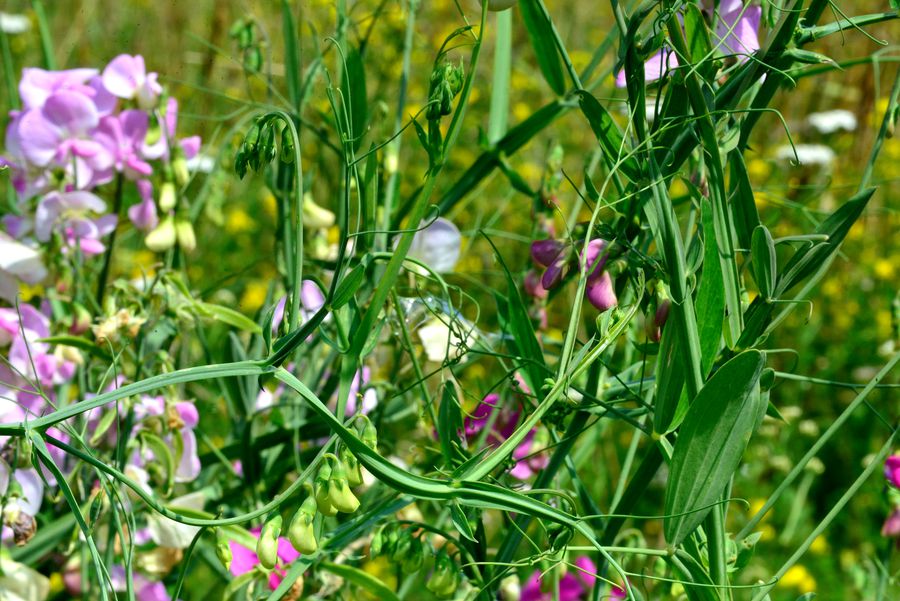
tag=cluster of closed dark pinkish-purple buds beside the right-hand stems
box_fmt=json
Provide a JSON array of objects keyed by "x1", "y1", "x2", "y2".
[{"x1": 525, "y1": 238, "x2": 619, "y2": 313}]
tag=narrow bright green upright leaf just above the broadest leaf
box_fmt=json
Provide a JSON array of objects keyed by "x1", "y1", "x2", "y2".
[{"x1": 697, "y1": 198, "x2": 725, "y2": 377}]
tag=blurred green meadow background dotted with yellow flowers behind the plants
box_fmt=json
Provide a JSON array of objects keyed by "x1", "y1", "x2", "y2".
[{"x1": 0, "y1": 0, "x2": 900, "y2": 599}]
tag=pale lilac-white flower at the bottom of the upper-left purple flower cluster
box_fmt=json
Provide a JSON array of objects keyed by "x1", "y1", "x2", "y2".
[{"x1": 34, "y1": 190, "x2": 117, "y2": 256}]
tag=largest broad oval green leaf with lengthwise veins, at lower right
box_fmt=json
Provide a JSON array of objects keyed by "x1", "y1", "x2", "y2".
[{"x1": 664, "y1": 350, "x2": 766, "y2": 546}]
